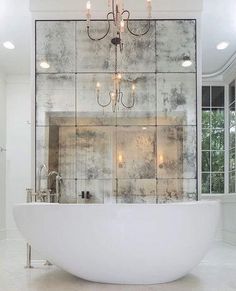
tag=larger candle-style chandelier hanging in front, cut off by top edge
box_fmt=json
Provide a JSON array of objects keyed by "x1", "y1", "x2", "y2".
[{"x1": 86, "y1": 0, "x2": 152, "y2": 52}]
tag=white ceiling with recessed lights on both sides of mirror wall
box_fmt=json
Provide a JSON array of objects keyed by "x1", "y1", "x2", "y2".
[{"x1": 0, "y1": 0, "x2": 236, "y2": 74}]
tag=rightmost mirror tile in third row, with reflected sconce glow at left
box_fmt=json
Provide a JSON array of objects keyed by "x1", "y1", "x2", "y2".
[{"x1": 157, "y1": 126, "x2": 196, "y2": 178}]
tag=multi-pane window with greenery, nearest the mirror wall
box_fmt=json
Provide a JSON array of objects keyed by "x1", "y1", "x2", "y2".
[{"x1": 202, "y1": 86, "x2": 225, "y2": 194}]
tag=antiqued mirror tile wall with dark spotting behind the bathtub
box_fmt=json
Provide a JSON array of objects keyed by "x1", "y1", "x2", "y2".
[{"x1": 35, "y1": 20, "x2": 197, "y2": 203}]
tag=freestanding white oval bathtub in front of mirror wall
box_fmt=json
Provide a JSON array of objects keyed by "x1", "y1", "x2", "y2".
[{"x1": 14, "y1": 201, "x2": 219, "y2": 284}]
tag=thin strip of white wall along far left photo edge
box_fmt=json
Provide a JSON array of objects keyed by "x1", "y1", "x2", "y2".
[{"x1": 0, "y1": 76, "x2": 6, "y2": 240}]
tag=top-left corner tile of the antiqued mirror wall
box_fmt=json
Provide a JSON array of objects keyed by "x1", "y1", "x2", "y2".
[{"x1": 36, "y1": 21, "x2": 75, "y2": 73}]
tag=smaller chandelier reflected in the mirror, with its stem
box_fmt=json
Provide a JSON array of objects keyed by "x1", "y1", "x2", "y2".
[{"x1": 96, "y1": 44, "x2": 135, "y2": 112}]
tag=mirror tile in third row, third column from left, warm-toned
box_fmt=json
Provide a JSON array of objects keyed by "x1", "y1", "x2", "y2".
[{"x1": 116, "y1": 126, "x2": 156, "y2": 179}]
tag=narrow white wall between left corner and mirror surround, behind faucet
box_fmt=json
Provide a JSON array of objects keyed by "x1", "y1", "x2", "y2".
[{"x1": 6, "y1": 75, "x2": 31, "y2": 238}]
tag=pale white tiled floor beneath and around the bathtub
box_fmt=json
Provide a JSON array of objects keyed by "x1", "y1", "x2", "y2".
[{"x1": 0, "y1": 240, "x2": 236, "y2": 291}]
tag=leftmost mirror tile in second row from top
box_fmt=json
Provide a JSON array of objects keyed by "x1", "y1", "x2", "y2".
[{"x1": 36, "y1": 74, "x2": 75, "y2": 126}]
